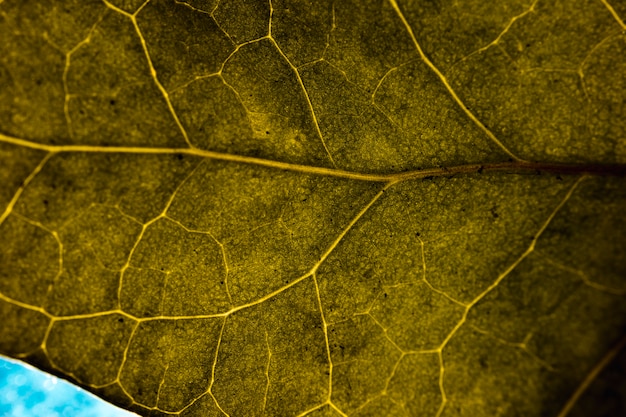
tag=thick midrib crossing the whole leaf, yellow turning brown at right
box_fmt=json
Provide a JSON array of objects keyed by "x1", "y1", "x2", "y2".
[{"x1": 0, "y1": 134, "x2": 626, "y2": 182}]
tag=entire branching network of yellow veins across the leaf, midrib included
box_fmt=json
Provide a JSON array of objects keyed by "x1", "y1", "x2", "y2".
[{"x1": 0, "y1": 0, "x2": 626, "y2": 417}]
